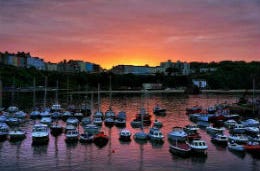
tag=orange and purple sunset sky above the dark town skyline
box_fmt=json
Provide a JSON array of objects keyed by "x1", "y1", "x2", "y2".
[{"x1": 0, "y1": 0, "x2": 260, "y2": 69}]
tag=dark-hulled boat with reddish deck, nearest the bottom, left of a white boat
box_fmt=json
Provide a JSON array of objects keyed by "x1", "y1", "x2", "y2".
[{"x1": 170, "y1": 141, "x2": 191, "y2": 157}]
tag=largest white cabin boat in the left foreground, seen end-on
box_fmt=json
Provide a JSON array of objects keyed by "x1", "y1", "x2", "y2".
[{"x1": 32, "y1": 124, "x2": 49, "y2": 144}]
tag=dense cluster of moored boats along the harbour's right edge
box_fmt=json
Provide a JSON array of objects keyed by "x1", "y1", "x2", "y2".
[{"x1": 186, "y1": 105, "x2": 260, "y2": 155}]
